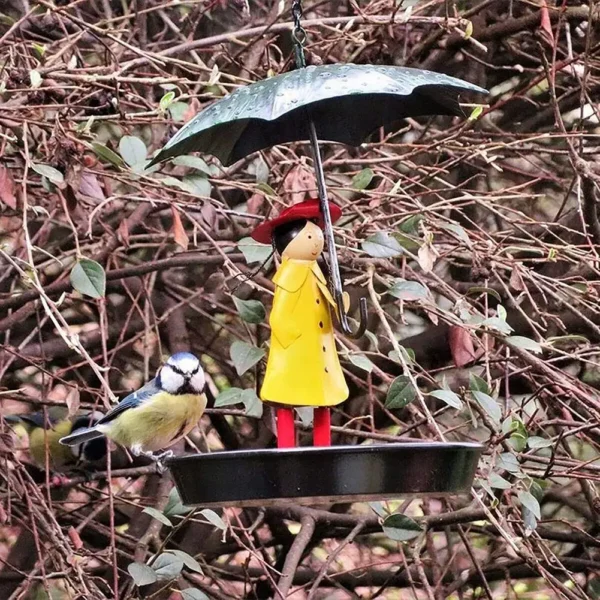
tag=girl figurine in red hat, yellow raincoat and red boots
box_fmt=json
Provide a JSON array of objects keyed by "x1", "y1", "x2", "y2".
[{"x1": 252, "y1": 200, "x2": 348, "y2": 448}]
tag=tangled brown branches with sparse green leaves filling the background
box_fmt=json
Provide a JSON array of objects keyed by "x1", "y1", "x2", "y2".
[{"x1": 0, "y1": 0, "x2": 600, "y2": 600}]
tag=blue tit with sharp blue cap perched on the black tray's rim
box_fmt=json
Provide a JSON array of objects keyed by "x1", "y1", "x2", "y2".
[{"x1": 60, "y1": 352, "x2": 206, "y2": 462}]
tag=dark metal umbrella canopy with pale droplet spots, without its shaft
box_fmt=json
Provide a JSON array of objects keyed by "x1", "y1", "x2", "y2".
[{"x1": 152, "y1": 64, "x2": 487, "y2": 166}]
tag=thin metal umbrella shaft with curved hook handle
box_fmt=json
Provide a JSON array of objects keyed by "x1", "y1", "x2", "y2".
[{"x1": 307, "y1": 113, "x2": 367, "y2": 339}]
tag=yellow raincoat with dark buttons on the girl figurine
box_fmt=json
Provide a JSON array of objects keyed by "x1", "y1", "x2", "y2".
[{"x1": 260, "y1": 257, "x2": 348, "y2": 406}]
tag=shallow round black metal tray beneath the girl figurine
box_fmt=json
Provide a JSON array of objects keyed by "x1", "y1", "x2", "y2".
[{"x1": 167, "y1": 442, "x2": 483, "y2": 507}]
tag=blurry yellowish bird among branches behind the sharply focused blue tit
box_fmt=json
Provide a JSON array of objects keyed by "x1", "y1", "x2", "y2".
[{"x1": 4, "y1": 412, "x2": 107, "y2": 472}]
